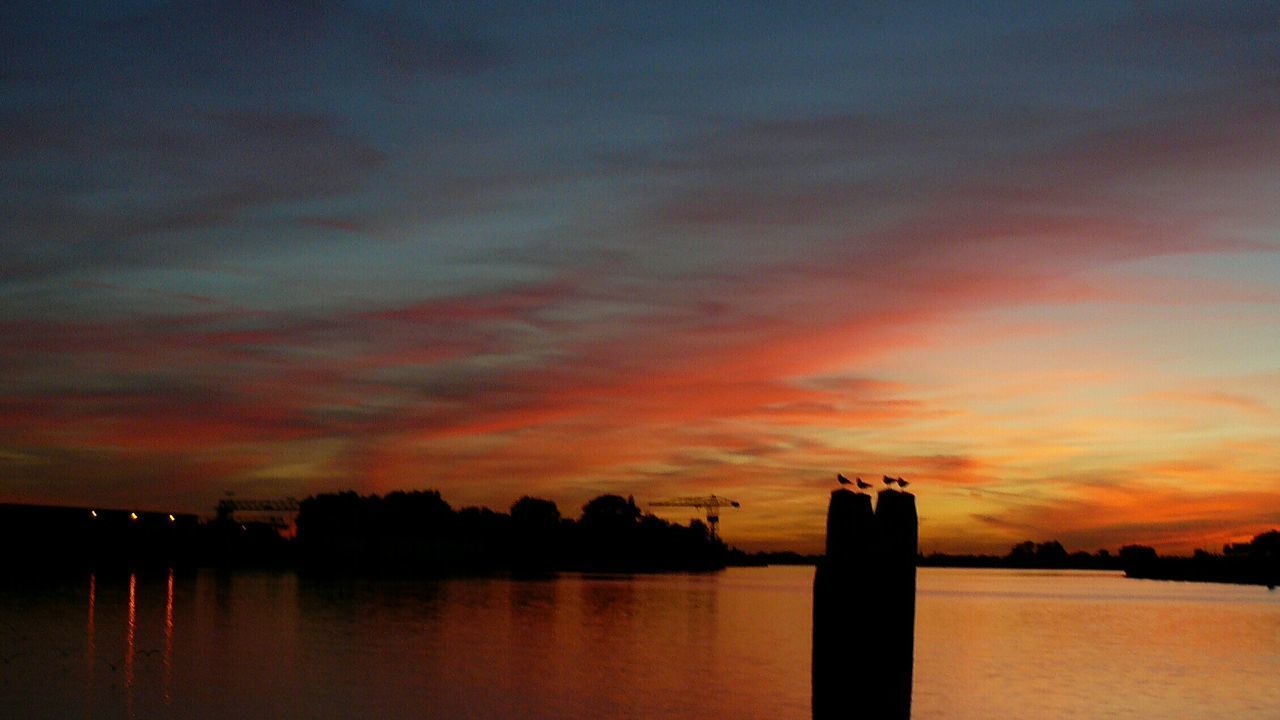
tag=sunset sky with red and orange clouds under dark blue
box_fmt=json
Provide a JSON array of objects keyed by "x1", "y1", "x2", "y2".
[{"x1": 0, "y1": 0, "x2": 1280, "y2": 552}]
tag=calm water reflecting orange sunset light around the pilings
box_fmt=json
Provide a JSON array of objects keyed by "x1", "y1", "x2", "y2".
[{"x1": 0, "y1": 568, "x2": 1280, "y2": 720}]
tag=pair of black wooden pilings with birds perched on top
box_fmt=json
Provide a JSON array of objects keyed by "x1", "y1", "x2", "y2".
[{"x1": 813, "y1": 488, "x2": 919, "y2": 720}]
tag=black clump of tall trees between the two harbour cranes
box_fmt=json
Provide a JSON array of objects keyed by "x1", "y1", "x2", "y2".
[{"x1": 296, "y1": 491, "x2": 727, "y2": 575}]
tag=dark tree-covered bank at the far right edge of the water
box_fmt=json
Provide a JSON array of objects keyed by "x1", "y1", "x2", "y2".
[{"x1": 1120, "y1": 530, "x2": 1280, "y2": 588}]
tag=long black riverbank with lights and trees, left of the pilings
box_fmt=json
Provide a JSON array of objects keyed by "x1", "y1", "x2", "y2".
[{"x1": 0, "y1": 491, "x2": 728, "y2": 577}]
